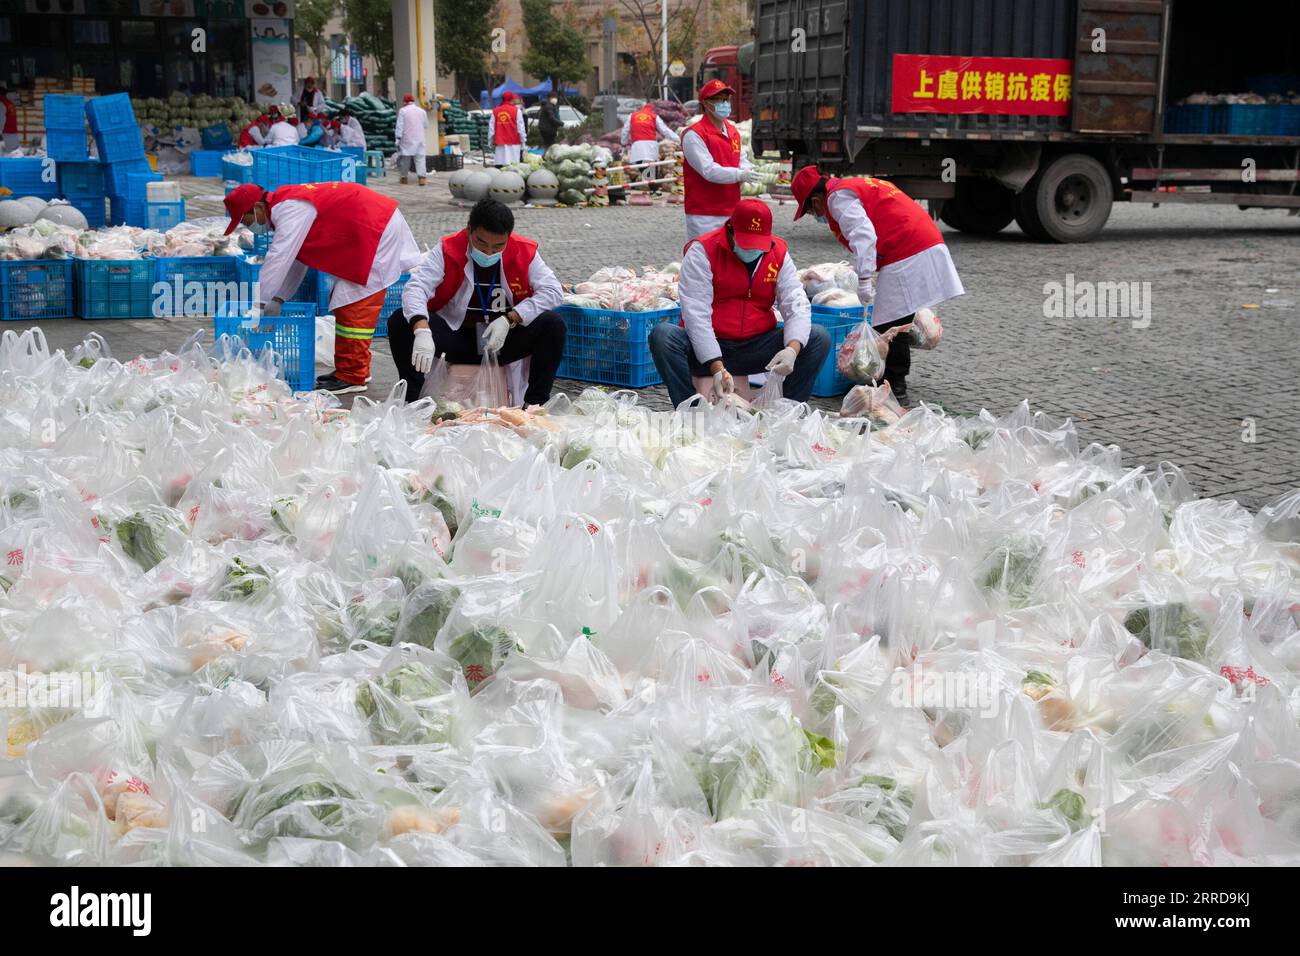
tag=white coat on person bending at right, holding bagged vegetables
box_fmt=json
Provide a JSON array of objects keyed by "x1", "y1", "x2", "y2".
[{"x1": 827, "y1": 189, "x2": 966, "y2": 325}]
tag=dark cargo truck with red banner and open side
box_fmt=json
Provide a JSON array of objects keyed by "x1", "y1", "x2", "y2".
[{"x1": 753, "y1": 0, "x2": 1300, "y2": 242}]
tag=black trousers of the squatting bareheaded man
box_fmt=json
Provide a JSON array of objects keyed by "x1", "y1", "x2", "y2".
[{"x1": 389, "y1": 311, "x2": 564, "y2": 405}]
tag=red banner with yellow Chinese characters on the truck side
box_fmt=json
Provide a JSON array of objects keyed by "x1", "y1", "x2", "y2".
[{"x1": 892, "y1": 53, "x2": 1074, "y2": 116}]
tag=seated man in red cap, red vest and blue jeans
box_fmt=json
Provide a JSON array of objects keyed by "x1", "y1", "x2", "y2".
[{"x1": 650, "y1": 199, "x2": 831, "y2": 407}]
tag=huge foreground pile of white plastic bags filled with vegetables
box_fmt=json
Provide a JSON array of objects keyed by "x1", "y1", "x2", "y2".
[{"x1": 0, "y1": 332, "x2": 1300, "y2": 866}]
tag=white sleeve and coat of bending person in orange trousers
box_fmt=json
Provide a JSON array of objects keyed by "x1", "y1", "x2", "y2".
[{"x1": 257, "y1": 199, "x2": 420, "y2": 308}]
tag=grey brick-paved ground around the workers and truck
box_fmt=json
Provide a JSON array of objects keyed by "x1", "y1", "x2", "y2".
[{"x1": 14, "y1": 173, "x2": 1300, "y2": 509}]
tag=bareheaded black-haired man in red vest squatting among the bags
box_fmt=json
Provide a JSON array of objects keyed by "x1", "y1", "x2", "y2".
[{"x1": 389, "y1": 199, "x2": 564, "y2": 405}]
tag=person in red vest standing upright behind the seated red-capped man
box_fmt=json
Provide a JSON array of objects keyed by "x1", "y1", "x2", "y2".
[{"x1": 681, "y1": 79, "x2": 761, "y2": 242}]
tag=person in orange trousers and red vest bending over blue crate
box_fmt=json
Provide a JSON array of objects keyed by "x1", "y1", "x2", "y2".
[{"x1": 226, "y1": 182, "x2": 420, "y2": 395}]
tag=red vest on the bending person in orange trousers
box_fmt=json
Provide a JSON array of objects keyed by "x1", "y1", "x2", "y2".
[{"x1": 267, "y1": 182, "x2": 398, "y2": 285}]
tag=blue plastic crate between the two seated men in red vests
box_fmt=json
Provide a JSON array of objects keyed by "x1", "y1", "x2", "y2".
[{"x1": 556, "y1": 306, "x2": 681, "y2": 389}]
